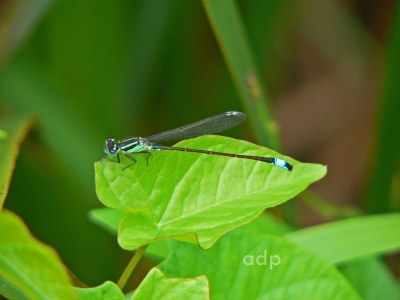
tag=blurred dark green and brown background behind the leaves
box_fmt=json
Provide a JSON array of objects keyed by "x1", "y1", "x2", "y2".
[{"x1": 0, "y1": 0, "x2": 400, "y2": 285}]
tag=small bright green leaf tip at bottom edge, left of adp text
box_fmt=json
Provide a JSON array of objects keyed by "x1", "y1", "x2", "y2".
[{"x1": 132, "y1": 268, "x2": 209, "y2": 300}]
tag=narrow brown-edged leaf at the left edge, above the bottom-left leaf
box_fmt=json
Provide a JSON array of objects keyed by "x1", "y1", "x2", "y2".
[{"x1": 0, "y1": 116, "x2": 33, "y2": 210}]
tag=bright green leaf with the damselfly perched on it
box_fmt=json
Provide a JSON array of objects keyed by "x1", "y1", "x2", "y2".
[{"x1": 95, "y1": 136, "x2": 326, "y2": 249}]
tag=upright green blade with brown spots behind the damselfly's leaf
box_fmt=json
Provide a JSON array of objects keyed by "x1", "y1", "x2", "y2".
[{"x1": 203, "y1": 0, "x2": 281, "y2": 151}]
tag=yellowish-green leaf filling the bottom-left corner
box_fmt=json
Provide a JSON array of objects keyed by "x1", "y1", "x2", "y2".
[{"x1": 0, "y1": 210, "x2": 78, "y2": 299}]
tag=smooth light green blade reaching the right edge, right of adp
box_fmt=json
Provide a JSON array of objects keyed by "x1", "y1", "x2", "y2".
[{"x1": 286, "y1": 214, "x2": 400, "y2": 263}]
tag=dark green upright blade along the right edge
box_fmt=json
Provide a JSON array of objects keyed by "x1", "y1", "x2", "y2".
[{"x1": 367, "y1": 3, "x2": 400, "y2": 213}]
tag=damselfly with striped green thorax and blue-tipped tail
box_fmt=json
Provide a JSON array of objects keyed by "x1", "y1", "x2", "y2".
[{"x1": 104, "y1": 111, "x2": 293, "y2": 171}]
